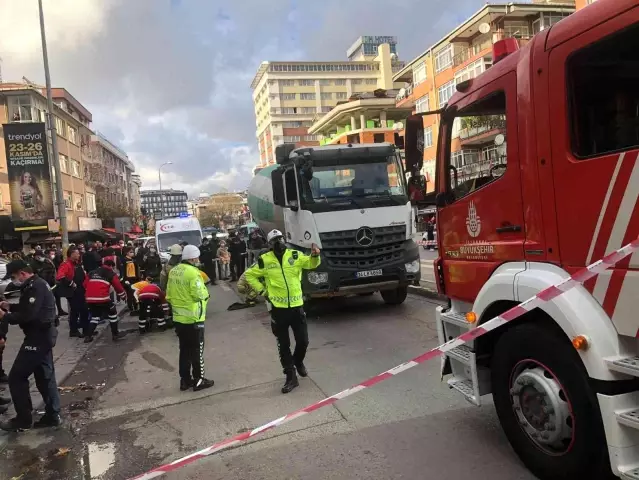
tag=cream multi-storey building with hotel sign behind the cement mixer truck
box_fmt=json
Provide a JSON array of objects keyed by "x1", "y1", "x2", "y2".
[{"x1": 251, "y1": 36, "x2": 403, "y2": 168}]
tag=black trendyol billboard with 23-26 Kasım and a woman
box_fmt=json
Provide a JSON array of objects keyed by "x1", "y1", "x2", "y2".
[{"x1": 3, "y1": 123, "x2": 54, "y2": 231}]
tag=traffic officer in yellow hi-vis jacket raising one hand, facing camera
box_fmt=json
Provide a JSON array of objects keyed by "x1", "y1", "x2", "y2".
[{"x1": 245, "y1": 230, "x2": 321, "y2": 393}]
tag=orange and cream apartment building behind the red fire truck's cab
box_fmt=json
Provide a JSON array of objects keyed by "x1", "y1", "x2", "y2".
[{"x1": 393, "y1": 0, "x2": 575, "y2": 191}]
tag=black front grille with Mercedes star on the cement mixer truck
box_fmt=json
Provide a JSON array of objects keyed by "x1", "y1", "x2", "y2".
[{"x1": 320, "y1": 225, "x2": 406, "y2": 270}]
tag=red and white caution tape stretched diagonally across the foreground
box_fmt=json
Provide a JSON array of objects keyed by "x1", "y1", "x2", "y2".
[{"x1": 130, "y1": 238, "x2": 639, "y2": 480}]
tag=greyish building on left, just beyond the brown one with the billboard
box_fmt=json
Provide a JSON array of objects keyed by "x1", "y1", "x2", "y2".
[{"x1": 82, "y1": 131, "x2": 141, "y2": 212}]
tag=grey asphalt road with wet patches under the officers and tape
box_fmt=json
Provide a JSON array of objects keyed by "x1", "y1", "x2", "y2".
[{"x1": 0, "y1": 282, "x2": 534, "y2": 480}]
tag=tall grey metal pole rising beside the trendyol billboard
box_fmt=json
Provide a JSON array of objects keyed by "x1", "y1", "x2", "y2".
[{"x1": 38, "y1": 0, "x2": 69, "y2": 249}]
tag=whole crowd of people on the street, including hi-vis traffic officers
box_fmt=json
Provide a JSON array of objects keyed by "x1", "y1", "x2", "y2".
[{"x1": 0, "y1": 230, "x2": 312, "y2": 431}]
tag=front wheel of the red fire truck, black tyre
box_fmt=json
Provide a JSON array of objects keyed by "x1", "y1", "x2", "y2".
[{"x1": 491, "y1": 324, "x2": 612, "y2": 480}]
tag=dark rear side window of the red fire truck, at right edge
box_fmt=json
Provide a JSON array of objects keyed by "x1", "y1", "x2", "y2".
[{"x1": 565, "y1": 24, "x2": 639, "y2": 158}]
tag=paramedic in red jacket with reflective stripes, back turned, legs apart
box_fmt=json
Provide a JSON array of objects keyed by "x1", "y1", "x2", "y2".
[{"x1": 84, "y1": 260, "x2": 126, "y2": 343}]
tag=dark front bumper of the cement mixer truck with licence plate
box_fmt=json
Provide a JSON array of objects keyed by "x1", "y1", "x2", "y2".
[{"x1": 302, "y1": 240, "x2": 421, "y2": 298}]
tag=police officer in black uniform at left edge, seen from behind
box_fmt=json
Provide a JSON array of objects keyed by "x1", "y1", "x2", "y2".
[{"x1": 0, "y1": 260, "x2": 62, "y2": 432}]
